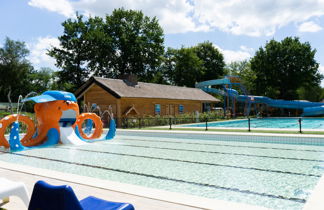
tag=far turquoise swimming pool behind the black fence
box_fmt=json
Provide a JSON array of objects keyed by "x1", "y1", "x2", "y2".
[{"x1": 182, "y1": 118, "x2": 324, "y2": 130}]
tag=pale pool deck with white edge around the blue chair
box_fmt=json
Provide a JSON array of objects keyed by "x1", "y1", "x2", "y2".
[{"x1": 0, "y1": 161, "x2": 267, "y2": 210}]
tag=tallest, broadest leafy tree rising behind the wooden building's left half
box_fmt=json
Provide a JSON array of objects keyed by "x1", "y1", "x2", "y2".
[{"x1": 49, "y1": 9, "x2": 164, "y2": 89}]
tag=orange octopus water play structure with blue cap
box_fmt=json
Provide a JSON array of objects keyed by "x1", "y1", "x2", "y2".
[{"x1": 0, "y1": 91, "x2": 116, "y2": 151}]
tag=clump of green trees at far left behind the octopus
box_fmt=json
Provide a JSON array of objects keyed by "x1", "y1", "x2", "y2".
[{"x1": 0, "y1": 38, "x2": 60, "y2": 103}]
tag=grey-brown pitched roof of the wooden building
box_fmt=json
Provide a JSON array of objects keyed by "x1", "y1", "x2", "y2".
[{"x1": 75, "y1": 77, "x2": 220, "y2": 102}]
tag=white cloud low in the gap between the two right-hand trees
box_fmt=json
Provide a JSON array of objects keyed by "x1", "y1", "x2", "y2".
[{"x1": 214, "y1": 45, "x2": 254, "y2": 63}]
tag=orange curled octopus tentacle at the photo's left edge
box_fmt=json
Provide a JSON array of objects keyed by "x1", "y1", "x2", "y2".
[{"x1": 0, "y1": 114, "x2": 36, "y2": 148}]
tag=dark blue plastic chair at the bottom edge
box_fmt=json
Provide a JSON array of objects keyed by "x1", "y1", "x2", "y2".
[{"x1": 28, "y1": 181, "x2": 134, "y2": 210}]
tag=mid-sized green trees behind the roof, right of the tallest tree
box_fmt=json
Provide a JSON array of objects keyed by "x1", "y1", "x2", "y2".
[{"x1": 161, "y1": 42, "x2": 225, "y2": 87}]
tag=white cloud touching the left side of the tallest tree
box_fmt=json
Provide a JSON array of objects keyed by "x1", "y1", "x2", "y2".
[{"x1": 27, "y1": 37, "x2": 60, "y2": 69}]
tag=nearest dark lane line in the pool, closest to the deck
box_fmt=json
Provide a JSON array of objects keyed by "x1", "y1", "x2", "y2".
[{"x1": 0, "y1": 151, "x2": 306, "y2": 203}]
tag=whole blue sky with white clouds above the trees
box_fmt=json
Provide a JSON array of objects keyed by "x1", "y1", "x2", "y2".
[{"x1": 0, "y1": 0, "x2": 324, "y2": 86}]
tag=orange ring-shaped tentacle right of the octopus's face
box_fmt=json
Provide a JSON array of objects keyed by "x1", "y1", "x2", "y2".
[{"x1": 73, "y1": 113, "x2": 103, "y2": 140}]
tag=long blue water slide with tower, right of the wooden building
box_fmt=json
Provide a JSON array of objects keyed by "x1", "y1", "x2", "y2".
[{"x1": 196, "y1": 76, "x2": 324, "y2": 117}]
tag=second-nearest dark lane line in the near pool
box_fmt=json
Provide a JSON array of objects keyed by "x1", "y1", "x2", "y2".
[{"x1": 57, "y1": 147, "x2": 321, "y2": 177}]
